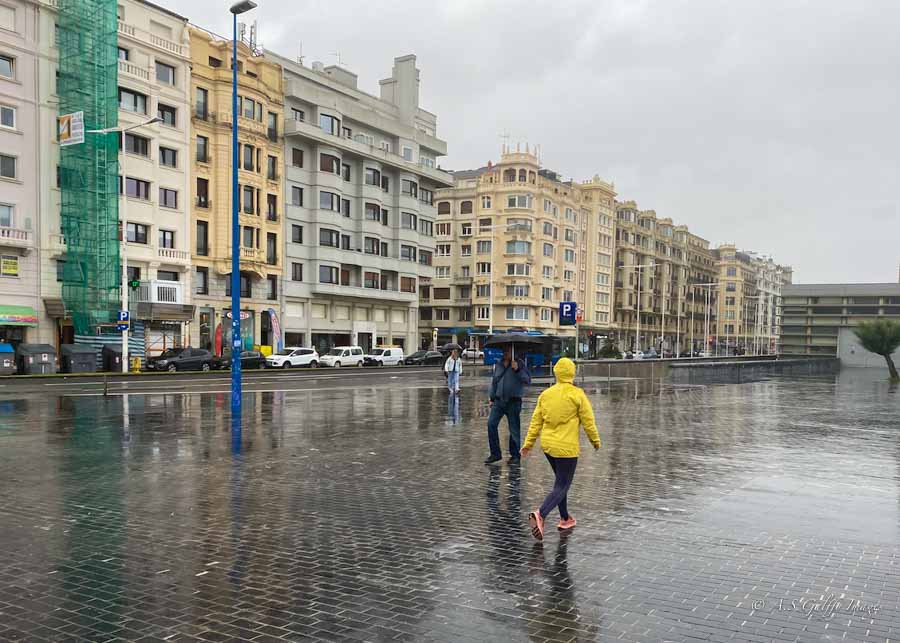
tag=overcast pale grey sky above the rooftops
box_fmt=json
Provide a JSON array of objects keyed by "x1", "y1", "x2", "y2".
[{"x1": 169, "y1": 0, "x2": 900, "y2": 283}]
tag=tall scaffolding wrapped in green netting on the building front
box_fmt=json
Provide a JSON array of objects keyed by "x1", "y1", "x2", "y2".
[{"x1": 57, "y1": 0, "x2": 122, "y2": 335}]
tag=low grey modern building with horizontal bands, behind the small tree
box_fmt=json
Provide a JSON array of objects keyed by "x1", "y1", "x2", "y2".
[{"x1": 779, "y1": 283, "x2": 900, "y2": 367}]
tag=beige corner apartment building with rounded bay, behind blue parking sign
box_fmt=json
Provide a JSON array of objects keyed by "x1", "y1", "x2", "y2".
[{"x1": 419, "y1": 149, "x2": 615, "y2": 352}]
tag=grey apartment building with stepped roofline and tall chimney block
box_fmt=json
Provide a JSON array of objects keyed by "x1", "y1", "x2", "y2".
[{"x1": 274, "y1": 55, "x2": 452, "y2": 353}]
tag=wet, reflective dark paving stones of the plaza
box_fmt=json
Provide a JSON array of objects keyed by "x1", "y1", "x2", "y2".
[{"x1": 0, "y1": 371, "x2": 900, "y2": 642}]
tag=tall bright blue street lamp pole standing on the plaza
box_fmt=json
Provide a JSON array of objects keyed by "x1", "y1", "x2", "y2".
[{"x1": 229, "y1": 0, "x2": 256, "y2": 420}]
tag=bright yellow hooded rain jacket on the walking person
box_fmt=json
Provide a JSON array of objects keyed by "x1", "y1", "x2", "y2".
[{"x1": 523, "y1": 357, "x2": 600, "y2": 458}]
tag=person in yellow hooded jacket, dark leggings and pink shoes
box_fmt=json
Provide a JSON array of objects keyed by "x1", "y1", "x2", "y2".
[{"x1": 522, "y1": 357, "x2": 600, "y2": 540}]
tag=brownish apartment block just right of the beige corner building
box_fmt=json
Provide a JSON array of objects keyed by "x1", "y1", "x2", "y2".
[{"x1": 614, "y1": 201, "x2": 717, "y2": 352}]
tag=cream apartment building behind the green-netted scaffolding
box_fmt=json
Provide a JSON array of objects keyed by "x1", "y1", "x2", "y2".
[{"x1": 36, "y1": 0, "x2": 193, "y2": 354}]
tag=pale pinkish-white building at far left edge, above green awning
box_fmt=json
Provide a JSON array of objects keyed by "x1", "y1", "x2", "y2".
[{"x1": 0, "y1": 0, "x2": 41, "y2": 345}]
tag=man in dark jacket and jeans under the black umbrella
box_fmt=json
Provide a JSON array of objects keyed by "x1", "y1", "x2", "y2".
[{"x1": 484, "y1": 349, "x2": 531, "y2": 464}]
